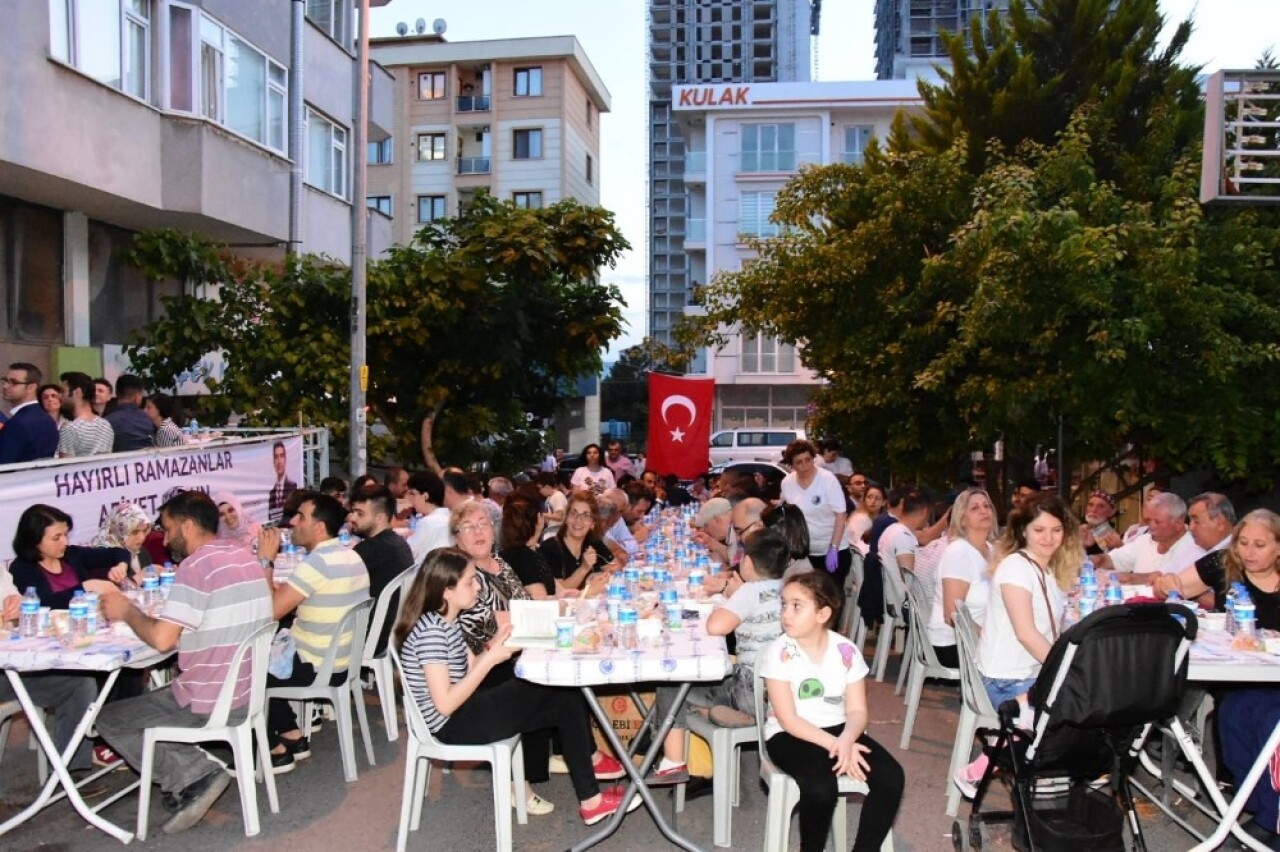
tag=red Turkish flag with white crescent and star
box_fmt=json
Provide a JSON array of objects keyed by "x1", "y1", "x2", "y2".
[{"x1": 644, "y1": 372, "x2": 716, "y2": 480}]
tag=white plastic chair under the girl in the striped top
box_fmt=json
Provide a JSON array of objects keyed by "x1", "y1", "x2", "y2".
[{"x1": 388, "y1": 647, "x2": 529, "y2": 852}]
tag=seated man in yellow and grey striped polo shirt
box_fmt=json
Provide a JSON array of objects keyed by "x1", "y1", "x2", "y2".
[{"x1": 257, "y1": 493, "x2": 369, "y2": 773}]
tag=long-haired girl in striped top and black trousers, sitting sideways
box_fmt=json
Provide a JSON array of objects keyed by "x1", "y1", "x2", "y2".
[{"x1": 396, "y1": 548, "x2": 640, "y2": 825}]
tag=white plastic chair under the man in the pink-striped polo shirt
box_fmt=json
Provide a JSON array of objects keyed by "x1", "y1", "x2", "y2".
[{"x1": 137, "y1": 622, "x2": 280, "y2": 840}]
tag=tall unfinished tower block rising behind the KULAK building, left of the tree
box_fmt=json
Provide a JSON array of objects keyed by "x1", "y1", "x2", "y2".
[{"x1": 649, "y1": 0, "x2": 822, "y2": 343}]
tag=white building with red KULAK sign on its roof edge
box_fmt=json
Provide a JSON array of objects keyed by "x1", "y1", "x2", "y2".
[{"x1": 671, "y1": 81, "x2": 920, "y2": 431}]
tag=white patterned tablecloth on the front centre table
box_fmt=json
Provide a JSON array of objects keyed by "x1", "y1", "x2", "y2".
[{"x1": 516, "y1": 620, "x2": 733, "y2": 686}]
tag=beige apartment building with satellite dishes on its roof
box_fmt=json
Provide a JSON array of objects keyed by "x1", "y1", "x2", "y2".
[{"x1": 367, "y1": 35, "x2": 609, "y2": 243}]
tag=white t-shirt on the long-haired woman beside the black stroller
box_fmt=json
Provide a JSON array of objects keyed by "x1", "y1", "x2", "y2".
[{"x1": 978, "y1": 553, "x2": 1066, "y2": 679}]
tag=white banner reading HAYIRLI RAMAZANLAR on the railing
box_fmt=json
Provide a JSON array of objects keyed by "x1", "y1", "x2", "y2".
[{"x1": 0, "y1": 435, "x2": 302, "y2": 562}]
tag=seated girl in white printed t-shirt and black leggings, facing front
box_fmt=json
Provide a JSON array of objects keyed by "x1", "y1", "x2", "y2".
[{"x1": 760, "y1": 572, "x2": 905, "y2": 852}]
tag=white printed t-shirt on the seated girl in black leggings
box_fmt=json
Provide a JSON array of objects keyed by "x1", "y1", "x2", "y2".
[{"x1": 756, "y1": 631, "x2": 868, "y2": 739}]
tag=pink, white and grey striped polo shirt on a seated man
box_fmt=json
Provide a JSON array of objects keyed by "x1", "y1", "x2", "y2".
[{"x1": 159, "y1": 540, "x2": 273, "y2": 714}]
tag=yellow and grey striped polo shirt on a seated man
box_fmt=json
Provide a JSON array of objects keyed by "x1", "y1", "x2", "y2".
[{"x1": 288, "y1": 539, "x2": 369, "y2": 669}]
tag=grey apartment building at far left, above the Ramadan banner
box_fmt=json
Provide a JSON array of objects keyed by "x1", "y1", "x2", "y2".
[{"x1": 0, "y1": 0, "x2": 392, "y2": 379}]
